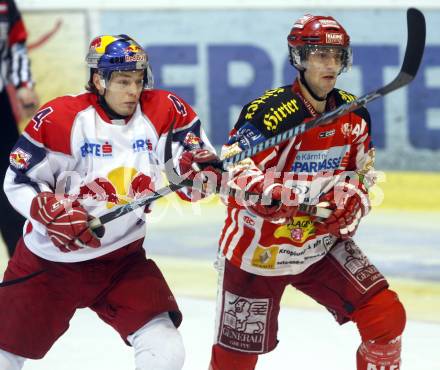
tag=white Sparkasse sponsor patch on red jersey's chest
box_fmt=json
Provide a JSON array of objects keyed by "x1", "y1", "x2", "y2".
[{"x1": 292, "y1": 145, "x2": 350, "y2": 174}]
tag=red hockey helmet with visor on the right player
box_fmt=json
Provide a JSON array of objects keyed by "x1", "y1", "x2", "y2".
[{"x1": 287, "y1": 14, "x2": 353, "y2": 73}]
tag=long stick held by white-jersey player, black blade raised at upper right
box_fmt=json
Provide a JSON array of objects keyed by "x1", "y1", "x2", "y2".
[{"x1": 86, "y1": 8, "x2": 426, "y2": 232}]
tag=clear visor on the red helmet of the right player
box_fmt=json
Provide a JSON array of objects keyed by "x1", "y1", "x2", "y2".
[{"x1": 289, "y1": 45, "x2": 353, "y2": 74}]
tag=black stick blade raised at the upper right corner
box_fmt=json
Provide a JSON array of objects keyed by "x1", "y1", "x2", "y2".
[{"x1": 402, "y1": 8, "x2": 426, "y2": 78}]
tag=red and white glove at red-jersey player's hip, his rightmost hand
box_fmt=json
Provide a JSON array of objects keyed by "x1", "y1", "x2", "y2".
[{"x1": 315, "y1": 183, "x2": 370, "y2": 239}]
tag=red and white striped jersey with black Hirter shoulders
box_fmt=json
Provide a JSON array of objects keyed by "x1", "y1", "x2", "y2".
[{"x1": 220, "y1": 83, "x2": 374, "y2": 276}]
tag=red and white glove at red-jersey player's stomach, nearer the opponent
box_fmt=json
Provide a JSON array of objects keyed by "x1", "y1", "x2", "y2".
[{"x1": 245, "y1": 180, "x2": 298, "y2": 223}]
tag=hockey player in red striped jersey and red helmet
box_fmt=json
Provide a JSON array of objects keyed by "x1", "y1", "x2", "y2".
[{"x1": 210, "y1": 15, "x2": 406, "y2": 370}]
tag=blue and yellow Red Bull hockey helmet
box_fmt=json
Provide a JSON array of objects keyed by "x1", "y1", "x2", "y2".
[{"x1": 86, "y1": 35, "x2": 154, "y2": 89}]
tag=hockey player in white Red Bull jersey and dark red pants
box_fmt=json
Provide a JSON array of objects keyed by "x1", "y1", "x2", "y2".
[{"x1": 0, "y1": 35, "x2": 215, "y2": 370}]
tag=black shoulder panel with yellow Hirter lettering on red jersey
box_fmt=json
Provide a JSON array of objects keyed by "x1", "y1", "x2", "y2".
[{"x1": 239, "y1": 85, "x2": 307, "y2": 137}]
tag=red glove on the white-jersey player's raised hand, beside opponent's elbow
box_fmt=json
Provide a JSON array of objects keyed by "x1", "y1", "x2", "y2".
[{"x1": 179, "y1": 149, "x2": 222, "y2": 194}]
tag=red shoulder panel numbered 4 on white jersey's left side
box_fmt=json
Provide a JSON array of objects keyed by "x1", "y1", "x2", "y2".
[{"x1": 25, "y1": 93, "x2": 96, "y2": 154}]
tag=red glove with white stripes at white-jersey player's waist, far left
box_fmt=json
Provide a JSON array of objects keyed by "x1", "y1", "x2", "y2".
[{"x1": 31, "y1": 192, "x2": 101, "y2": 253}]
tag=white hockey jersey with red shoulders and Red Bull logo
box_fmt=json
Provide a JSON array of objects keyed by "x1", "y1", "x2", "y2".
[{"x1": 4, "y1": 90, "x2": 214, "y2": 262}]
